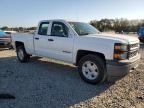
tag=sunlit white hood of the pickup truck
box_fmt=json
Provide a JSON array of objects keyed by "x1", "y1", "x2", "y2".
[{"x1": 85, "y1": 33, "x2": 139, "y2": 43}]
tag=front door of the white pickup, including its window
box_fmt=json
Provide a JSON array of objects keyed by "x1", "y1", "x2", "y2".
[{"x1": 48, "y1": 21, "x2": 74, "y2": 62}]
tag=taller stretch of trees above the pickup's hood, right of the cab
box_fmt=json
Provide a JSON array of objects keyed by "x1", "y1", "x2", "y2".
[{"x1": 90, "y1": 18, "x2": 144, "y2": 33}]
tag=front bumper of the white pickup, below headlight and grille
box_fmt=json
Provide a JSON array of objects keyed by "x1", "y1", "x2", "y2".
[{"x1": 107, "y1": 55, "x2": 140, "y2": 81}]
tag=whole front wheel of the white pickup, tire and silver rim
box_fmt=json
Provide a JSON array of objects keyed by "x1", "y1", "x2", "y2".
[{"x1": 78, "y1": 55, "x2": 106, "y2": 84}]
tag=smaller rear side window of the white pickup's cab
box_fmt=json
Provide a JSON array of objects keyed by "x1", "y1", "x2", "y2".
[{"x1": 38, "y1": 22, "x2": 49, "y2": 35}]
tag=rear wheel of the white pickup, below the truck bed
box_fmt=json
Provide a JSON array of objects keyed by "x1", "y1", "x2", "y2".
[{"x1": 16, "y1": 46, "x2": 30, "y2": 63}]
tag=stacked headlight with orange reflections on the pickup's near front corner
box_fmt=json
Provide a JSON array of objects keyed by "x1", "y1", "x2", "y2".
[{"x1": 114, "y1": 43, "x2": 128, "y2": 60}]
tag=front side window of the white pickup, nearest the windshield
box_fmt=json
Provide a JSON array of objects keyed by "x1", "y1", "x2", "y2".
[{"x1": 51, "y1": 22, "x2": 68, "y2": 37}]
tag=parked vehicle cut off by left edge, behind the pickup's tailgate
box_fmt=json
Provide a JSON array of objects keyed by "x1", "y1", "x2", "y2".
[{"x1": 0, "y1": 30, "x2": 11, "y2": 47}]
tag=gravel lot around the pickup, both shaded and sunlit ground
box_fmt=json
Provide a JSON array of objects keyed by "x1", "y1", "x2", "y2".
[{"x1": 0, "y1": 45, "x2": 144, "y2": 108}]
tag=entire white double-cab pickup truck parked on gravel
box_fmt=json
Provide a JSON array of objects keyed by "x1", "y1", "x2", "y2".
[{"x1": 12, "y1": 20, "x2": 140, "y2": 84}]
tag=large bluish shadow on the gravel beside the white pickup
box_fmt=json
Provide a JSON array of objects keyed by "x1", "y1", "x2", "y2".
[{"x1": 0, "y1": 57, "x2": 112, "y2": 108}]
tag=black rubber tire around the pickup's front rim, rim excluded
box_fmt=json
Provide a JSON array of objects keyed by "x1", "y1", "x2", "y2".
[{"x1": 78, "y1": 55, "x2": 106, "y2": 84}]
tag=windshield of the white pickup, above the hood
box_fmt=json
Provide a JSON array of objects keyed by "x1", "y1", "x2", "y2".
[{"x1": 69, "y1": 22, "x2": 100, "y2": 36}]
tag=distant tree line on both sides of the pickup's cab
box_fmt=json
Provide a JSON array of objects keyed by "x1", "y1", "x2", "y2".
[{"x1": 1, "y1": 18, "x2": 144, "y2": 33}]
